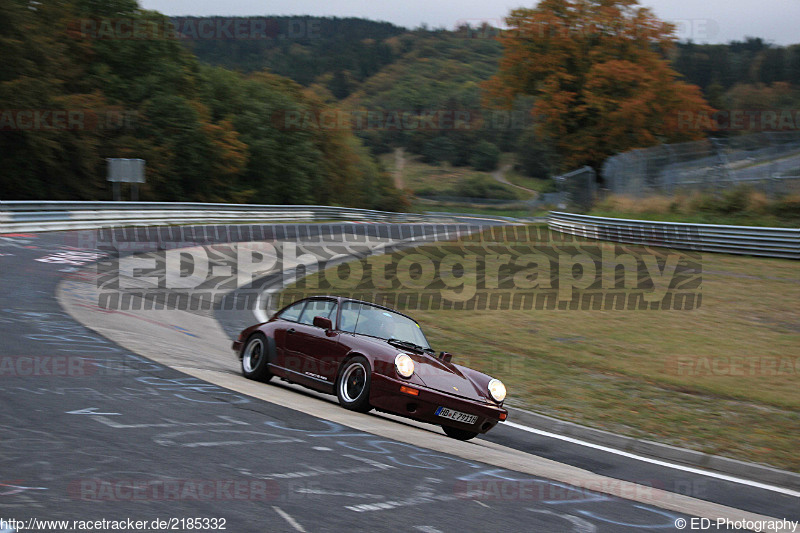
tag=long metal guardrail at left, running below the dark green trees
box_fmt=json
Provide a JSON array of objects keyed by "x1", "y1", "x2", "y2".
[{"x1": 0, "y1": 201, "x2": 466, "y2": 233}]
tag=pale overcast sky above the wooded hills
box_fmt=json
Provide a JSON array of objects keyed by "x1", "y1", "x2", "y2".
[{"x1": 139, "y1": 0, "x2": 800, "y2": 45}]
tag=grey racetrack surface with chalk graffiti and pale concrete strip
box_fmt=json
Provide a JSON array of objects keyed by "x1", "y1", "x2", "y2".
[{"x1": 0, "y1": 228, "x2": 799, "y2": 531}]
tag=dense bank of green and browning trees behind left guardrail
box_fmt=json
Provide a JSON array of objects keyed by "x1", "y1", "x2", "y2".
[{"x1": 0, "y1": 0, "x2": 407, "y2": 210}]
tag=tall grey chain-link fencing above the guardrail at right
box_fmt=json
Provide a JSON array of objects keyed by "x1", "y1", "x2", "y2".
[{"x1": 602, "y1": 131, "x2": 800, "y2": 197}]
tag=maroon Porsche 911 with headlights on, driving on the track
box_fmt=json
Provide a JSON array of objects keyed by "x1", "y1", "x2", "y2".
[{"x1": 233, "y1": 296, "x2": 508, "y2": 440}]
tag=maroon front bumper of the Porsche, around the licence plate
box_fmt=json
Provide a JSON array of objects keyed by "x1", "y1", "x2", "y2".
[{"x1": 369, "y1": 373, "x2": 508, "y2": 433}]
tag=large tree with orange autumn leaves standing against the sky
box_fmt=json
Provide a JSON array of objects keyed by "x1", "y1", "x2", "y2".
[{"x1": 484, "y1": 0, "x2": 713, "y2": 170}]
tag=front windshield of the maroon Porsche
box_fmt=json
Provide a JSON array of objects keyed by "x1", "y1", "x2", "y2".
[{"x1": 340, "y1": 302, "x2": 431, "y2": 350}]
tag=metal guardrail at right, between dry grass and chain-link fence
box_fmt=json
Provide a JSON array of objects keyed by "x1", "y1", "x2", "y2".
[{"x1": 547, "y1": 212, "x2": 800, "y2": 259}]
